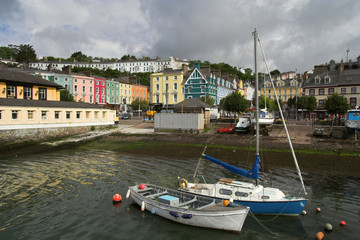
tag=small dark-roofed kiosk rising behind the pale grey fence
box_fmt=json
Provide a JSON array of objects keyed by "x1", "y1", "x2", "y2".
[{"x1": 174, "y1": 98, "x2": 211, "y2": 125}]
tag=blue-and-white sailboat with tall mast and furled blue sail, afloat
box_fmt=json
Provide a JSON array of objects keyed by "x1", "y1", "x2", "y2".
[{"x1": 179, "y1": 29, "x2": 307, "y2": 216}]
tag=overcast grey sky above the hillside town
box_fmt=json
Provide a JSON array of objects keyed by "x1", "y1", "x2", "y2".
[{"x1": 0, "y1": 0, "x2": 360, "y2": 73}]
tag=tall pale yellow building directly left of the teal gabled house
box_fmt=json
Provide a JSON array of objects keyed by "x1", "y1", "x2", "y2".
[{"x1": 150, "y1": 69, "x2": 187, "y2": 105}]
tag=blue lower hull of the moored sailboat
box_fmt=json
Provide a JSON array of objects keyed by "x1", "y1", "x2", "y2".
[{"x1": 234, "y1": 199, "x2": 307, "y2": 215}]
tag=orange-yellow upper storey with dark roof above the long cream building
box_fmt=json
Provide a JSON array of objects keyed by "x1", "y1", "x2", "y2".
[{"x1": 0, "y1": 69, "x2": 63, "y2": 101}]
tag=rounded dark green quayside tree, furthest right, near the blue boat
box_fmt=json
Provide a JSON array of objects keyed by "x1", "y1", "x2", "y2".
[{"x1": 325, "y1": 93, "x2": 350, "y2": 125}]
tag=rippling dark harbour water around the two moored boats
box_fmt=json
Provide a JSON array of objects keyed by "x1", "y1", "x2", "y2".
[{"x1": 0, "y1": 144, "x2": 360, "y2": 239}]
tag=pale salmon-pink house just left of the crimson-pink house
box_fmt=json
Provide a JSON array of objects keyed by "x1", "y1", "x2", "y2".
[{"x1": 72, "y1": 74, "x2": 95, "y2": 103}]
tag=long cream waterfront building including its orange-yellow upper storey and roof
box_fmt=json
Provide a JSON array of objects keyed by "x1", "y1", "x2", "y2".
[{"x1": 0, "y1": 68, "x2": 116, "y2": 132}]
